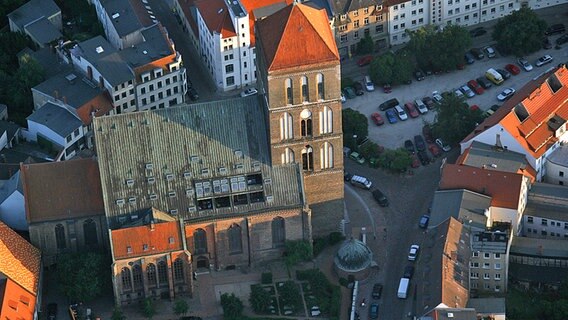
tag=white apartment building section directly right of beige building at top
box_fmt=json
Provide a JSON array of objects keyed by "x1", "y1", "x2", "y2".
[{"x1": 386, "y1": 0, "x2": 430, "y2": 45}]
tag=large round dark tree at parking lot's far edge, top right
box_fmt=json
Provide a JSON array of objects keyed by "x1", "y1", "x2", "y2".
[{"x1": 491, "y1": 7, "x2": 547, "y2": 57}]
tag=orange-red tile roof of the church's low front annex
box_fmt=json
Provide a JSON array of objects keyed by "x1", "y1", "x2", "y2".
[{"x1": 111, "y1": 221, "x2": 183, "y2": 259}]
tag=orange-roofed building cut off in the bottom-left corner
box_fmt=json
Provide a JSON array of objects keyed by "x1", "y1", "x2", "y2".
[{"x1": 0, "y1": 221, "x2": 43, "y2": 320}]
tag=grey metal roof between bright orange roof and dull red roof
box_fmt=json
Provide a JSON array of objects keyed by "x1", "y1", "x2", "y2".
[{"x1": 463, "y1": 141, "x2": 527, "y2": 173}]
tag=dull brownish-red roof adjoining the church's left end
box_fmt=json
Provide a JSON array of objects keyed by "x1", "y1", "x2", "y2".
[{"x1": 21, "y1": 159, "x2": 104, "y2": 224}]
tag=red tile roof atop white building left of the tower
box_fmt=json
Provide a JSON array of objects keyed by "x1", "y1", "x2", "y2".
[{"x1": 195, "y1": 0, "x2": 237, "y2": 38}]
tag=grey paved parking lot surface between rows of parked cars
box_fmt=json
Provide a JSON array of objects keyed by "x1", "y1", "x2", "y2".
[{"x1": 343, "y1": 36, "x2": 568, "y2": 149}]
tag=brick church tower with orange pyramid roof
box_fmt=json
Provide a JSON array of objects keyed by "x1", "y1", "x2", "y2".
[{"x1": 256, "y1": 3, "x2": 344, "y2": 235}]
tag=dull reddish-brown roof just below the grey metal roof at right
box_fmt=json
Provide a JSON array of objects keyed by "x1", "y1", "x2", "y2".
[{"x1": 439, "y1": 164, "x2": 523, "y2": 209}]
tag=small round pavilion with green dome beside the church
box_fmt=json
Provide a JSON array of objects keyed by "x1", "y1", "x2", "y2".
[{"x1": 334, "y1": 238, "x2": 373, "y2": 280}]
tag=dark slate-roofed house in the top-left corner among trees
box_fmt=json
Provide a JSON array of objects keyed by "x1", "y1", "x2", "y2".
[{"x1": 8, "y1": 0, "x2": 63, "y2": 47}]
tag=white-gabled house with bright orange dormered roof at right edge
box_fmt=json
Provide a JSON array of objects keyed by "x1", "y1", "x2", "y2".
[{"x1": 461, "y1": 65, "x2": 568, "y2": 181}]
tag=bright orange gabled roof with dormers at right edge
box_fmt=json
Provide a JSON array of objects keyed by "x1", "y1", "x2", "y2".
[{"x1": 463, "y1": 65, "x2": 568, "y2": 158}]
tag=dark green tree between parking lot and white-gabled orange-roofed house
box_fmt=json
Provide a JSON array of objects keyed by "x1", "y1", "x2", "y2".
[{"x1": 432, "y1": 93, "x2": 483, "y2": 145}]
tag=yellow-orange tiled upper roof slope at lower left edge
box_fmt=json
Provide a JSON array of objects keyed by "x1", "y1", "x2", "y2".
[{"x1": 0, "y1": 221, "x2": 41, "y2": 295}]
